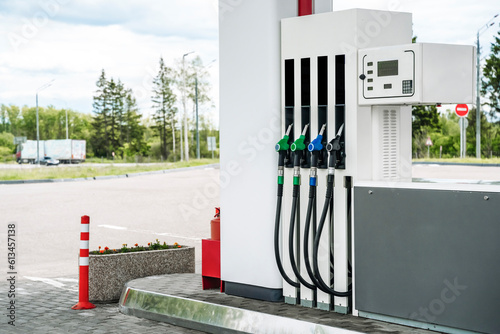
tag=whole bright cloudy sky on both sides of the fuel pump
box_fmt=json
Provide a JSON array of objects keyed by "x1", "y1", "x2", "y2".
[{"x1": 0, "y1": 0, "x2": 500, "y2": 122}]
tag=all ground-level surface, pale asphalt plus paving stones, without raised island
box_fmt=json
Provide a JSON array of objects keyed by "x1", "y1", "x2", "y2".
[{"x1": 0, "y1": 165, "x2": 500, "y2": 334}]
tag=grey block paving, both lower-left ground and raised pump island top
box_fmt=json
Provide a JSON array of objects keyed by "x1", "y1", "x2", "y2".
[{"x1": 0, "y1": 274, "x2": 436, "y2": 334}]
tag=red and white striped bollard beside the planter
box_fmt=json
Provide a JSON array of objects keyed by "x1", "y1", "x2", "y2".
[{"x1": 72, "y1": 216, "x2": 95, "y2": 310}]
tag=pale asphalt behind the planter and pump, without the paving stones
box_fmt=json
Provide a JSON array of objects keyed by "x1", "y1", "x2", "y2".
[{"x1": 0, "y1": 165, "x2": 500, "y2": 278}]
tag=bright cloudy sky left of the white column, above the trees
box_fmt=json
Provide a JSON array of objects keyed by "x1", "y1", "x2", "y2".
[{"x1": 0, "y1": 0, "x2": 218, "y2": 117}]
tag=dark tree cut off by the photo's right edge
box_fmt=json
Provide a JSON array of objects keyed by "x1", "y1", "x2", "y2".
[{"x1": 481, "y1": 32, "x2": 500, "y2": 123}]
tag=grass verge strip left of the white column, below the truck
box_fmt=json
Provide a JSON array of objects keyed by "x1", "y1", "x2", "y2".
[{"x1": 0, "y1": 159, "x2": 219, "y2": 181}]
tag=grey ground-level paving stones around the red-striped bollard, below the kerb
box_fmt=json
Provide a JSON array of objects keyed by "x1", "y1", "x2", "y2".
[{"x1": 0, "y1": 277, "x2": 202, "y2": 334}]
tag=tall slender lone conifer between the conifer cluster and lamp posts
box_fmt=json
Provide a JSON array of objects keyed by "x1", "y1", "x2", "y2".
[{"x1": 152, "y1": 58, "x2": 177, "y2": 159}]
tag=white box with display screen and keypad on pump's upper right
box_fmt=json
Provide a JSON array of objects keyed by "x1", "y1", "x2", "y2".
[{"x1": 358, "y1": 43, "x2": 475, "y2": 105}]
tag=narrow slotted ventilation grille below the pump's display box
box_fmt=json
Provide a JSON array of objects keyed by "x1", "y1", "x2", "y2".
[{"x1": 382, "y1": 109, "x2": 399, "y2": 180}]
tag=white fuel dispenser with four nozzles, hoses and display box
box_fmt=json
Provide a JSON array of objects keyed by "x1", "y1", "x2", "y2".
[{"x1": 275, "y1": 10, "x2": 475, "y2": 313}]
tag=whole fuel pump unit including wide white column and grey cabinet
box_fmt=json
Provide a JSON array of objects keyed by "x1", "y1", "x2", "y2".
[{"x1": 220, "y1": 4, "x2": 488, "y2": 333}]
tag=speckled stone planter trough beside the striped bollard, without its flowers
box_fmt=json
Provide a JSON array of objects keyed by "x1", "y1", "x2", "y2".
[{"x1": 89, "y1": 246, "x2": 195, "y2": 302}]
